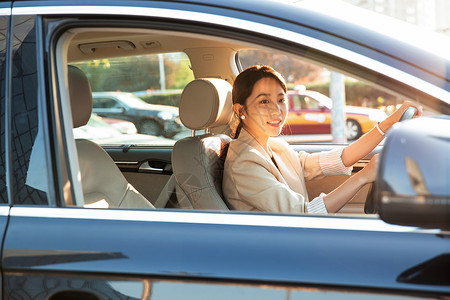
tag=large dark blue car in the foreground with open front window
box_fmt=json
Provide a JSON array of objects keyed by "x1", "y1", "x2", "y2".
[{"x1": 0, "y1": 0, "x2": 450, "y2": 300}]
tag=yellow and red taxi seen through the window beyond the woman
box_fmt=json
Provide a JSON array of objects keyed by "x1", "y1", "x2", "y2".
[{"x1": 283, "y1": 86, "x2": 387, "y2": 140}]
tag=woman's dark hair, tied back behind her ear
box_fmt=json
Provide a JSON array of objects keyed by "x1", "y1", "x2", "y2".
[{"x1": 232, "y1": 65, "x2": 287, "y2": 138}]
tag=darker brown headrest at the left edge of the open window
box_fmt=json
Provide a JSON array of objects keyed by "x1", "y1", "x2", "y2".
[{"x1": 68, "y1": 66, "x2": 92, "y2": 128}]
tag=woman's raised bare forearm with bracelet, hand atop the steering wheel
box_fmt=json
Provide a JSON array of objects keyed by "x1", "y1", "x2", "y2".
[{"x1": 341, "y1": 101, "x2": 422, "y2": 167}]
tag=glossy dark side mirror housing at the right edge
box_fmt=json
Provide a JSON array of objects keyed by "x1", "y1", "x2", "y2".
[{"x1": 375, "y1": 116, "x2": 450, "y2": 229}]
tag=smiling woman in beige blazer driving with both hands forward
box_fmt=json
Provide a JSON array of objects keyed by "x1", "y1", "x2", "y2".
[{"x1": 223, "y1": 66, "x2": 421, "y2": 213}]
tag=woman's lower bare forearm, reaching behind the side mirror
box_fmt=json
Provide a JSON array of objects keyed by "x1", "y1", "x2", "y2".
[{"x1": 323, "y1": 154, "x2": 378, "y2": 213}]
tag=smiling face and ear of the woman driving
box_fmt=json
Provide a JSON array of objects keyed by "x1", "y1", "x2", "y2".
[{"x1": 240, "y1": 77, "x2": 288, "y2": 142}]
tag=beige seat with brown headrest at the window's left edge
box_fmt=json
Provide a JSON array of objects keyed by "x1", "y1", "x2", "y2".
[{"x1": 68, "y1": 66, "x2": 153, "y2": 208}]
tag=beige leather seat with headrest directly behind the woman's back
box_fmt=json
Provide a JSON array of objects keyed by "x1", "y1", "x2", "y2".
[{"x1": 172, "y1": 78, "x2": 233, "y2": 210}]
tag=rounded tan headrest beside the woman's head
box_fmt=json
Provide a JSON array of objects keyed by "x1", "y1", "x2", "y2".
[{"x1": 179, "y1": 78, "x2": 233, "y2": 130}]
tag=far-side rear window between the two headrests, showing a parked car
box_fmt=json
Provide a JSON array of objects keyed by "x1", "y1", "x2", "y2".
[{"x1": 72, "y1": 52, "x2": 194, "y2": 145}]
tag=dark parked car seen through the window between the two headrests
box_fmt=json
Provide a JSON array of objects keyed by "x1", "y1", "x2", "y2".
[{"x1": 92, "y1": 92, "x2": 184, "y2": 138}]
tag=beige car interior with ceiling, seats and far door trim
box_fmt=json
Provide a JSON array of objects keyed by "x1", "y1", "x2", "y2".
[{"x1": 56, "y1": 27, "x2": 424, "y2": 215}]
